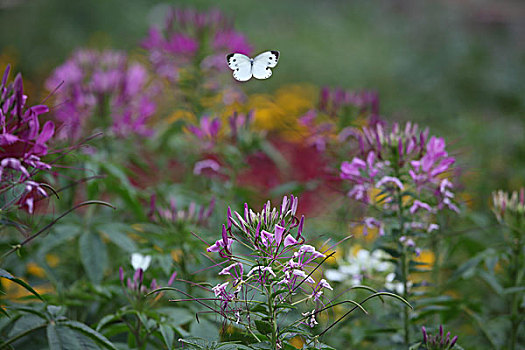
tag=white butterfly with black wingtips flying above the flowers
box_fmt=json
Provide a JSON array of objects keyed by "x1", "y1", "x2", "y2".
[{"x1": 226, "y1": 51, "x2": 279, "y2": 81}]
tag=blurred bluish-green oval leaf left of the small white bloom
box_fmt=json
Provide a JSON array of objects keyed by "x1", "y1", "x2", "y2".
[{"x1": 79, "y1": 232, "x2": 108, "y2": 284}]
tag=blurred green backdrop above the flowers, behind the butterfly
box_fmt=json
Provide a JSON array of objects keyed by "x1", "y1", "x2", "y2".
[{"x1": 0, "y1": 0, "x2": 525, "y2": 208}]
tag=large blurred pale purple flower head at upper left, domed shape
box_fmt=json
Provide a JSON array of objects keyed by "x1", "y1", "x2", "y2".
[{"x1": 46, "y1": 49, "x2": 156, "y2": 139}]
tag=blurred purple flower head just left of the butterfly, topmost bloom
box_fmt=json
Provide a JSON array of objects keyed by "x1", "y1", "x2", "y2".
[{"x1": 142, "y1": 8, "x2": 251, "y2": 81}]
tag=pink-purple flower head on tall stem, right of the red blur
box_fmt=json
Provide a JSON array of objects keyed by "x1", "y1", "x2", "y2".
[{"x1": 340, "y1": 123, "x2": 459, "y2": 214}]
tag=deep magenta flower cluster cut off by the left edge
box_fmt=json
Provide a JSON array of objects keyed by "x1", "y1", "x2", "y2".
[{"x1": 0, "y1": 66, "x2": 55, "y2": 213}]
